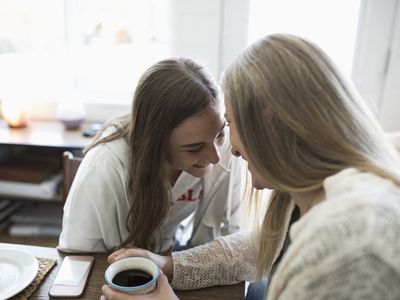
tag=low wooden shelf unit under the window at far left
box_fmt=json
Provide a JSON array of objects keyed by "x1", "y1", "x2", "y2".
[{"x1": 0, "y1": 121, "x2": 91, "y2": 247}]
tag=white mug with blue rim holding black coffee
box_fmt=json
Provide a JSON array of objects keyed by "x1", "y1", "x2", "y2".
[{"x1": 104, "y1": 257, "x2": 160, "y2": 295}]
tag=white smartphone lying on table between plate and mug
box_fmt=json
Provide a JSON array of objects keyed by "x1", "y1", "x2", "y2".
[{"x1": 49, "y1": 255, "x2": 94, "y2": 297}]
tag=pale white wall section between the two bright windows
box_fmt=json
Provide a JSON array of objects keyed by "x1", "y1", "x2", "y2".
[{"x1": 171, "y1": 0, "x2": 249, "y2": 79}]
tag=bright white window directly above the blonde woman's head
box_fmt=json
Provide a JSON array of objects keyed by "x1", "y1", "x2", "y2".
[{"x1": 248, "y1": 0, "x2": 360, "y2": 77}]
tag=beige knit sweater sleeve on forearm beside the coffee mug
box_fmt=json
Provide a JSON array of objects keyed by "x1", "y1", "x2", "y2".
[{"x1": 171, "y1": 232, "x2": 256, "y2": 290}]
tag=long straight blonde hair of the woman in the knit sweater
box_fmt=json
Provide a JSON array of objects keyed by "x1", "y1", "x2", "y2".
[{"x1": 222, "y1": 34, "x2": 400, "y2": 276}]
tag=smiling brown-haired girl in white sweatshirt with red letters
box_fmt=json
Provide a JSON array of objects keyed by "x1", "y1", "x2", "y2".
[{"x1": 58, "y1": 58, "x2": 242, "y2": 253}]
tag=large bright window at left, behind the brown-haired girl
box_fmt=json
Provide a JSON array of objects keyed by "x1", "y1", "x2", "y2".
[{"x1": 0, "y1": 0, "x2": 170, "y2": 104}]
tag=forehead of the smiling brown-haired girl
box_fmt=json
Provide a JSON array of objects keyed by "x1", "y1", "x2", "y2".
[{"x1": 170, "y1": 107, "x2": 224, "y2": 144}]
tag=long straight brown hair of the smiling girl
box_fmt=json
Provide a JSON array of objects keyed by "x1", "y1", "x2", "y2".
[{"x1": 85, "y1": 58, "x2": 219, "y2": 252}]
